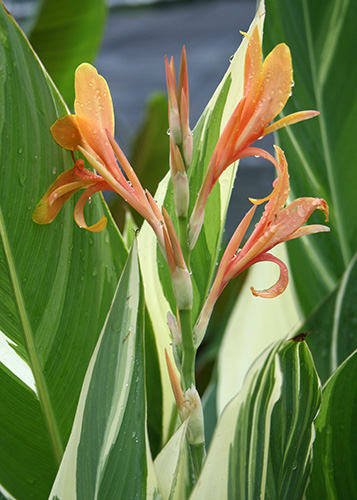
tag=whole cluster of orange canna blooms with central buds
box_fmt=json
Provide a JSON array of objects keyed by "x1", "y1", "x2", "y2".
[{"x1": 33, "y1": 28, "x2": 329, "y2": 347}]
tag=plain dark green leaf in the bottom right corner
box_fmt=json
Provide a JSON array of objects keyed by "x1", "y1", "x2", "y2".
[{"x1": 307, "y1": 351, "x2": 357, "y2": 500}]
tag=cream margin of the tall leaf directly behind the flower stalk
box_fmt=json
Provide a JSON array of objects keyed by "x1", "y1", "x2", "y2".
[{"x1": 138, "y1": 0, "x2": 265, "y2": 440}]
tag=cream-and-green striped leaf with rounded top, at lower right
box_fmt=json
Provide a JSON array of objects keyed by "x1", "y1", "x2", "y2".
[{"x1": 190, "y1": 341, "x2": 321, "y2": 500}]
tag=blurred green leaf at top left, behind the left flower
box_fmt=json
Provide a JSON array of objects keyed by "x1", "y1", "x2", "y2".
[{"x1": 29, "y1": 0, "x2": 107, "y2": 104}]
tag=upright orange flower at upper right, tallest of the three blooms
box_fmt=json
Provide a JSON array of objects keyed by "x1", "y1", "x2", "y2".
[{"x1": 190, "y1": 27, "x2": 319, "y2": 248}]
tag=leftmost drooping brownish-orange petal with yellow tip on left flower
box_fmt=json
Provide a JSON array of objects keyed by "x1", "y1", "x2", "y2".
[{"x1": 32, "y1": 168, "x2": 89, "y2": 224}]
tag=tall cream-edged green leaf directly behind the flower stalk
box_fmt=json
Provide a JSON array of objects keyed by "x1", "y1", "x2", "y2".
[{"x1": 138, "y1": 3, "x2": 264, "y2": 439}]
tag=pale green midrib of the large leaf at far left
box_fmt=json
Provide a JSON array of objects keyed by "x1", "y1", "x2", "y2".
[{"x1": 0, "y1": 208, "x2": 64, "y2": 464}]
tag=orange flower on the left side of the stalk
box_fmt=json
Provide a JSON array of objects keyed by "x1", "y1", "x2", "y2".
[{"x1": 32, "y1": 63, "x2": 164, "y2": 246}]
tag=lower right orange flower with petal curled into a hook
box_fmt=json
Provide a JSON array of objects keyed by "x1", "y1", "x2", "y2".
[{"x1": 195, "y1": 146, "x2": 330, "y2": 344}]
